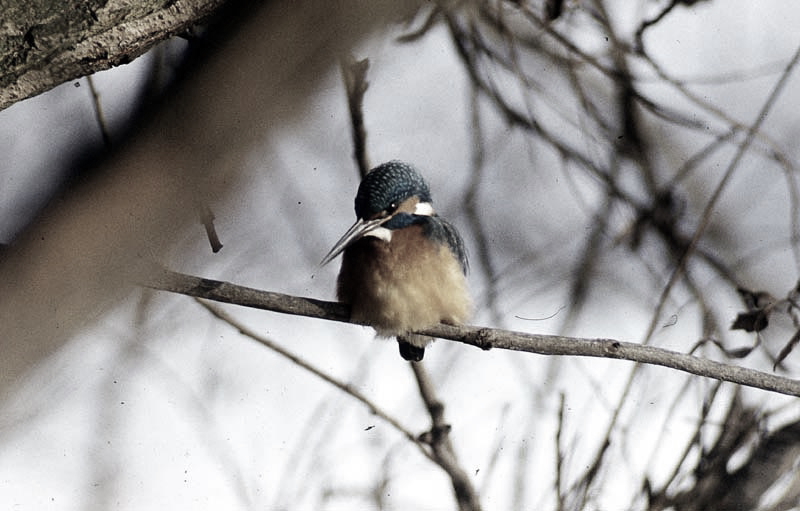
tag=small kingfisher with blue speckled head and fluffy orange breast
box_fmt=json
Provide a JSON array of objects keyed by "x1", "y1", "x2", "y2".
[{"x1": 321, "y1": 160, "x2": 472, "y2": 362}]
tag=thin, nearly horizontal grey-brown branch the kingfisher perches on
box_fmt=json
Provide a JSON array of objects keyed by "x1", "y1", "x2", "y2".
[{"x1": 140, "y1": 270, "x2": 800, "y2": 397}]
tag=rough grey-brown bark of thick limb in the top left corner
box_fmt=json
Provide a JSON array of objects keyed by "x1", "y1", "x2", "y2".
[{"x1": 0, "y1": 0, "x2": 224, "y2": 110}]
